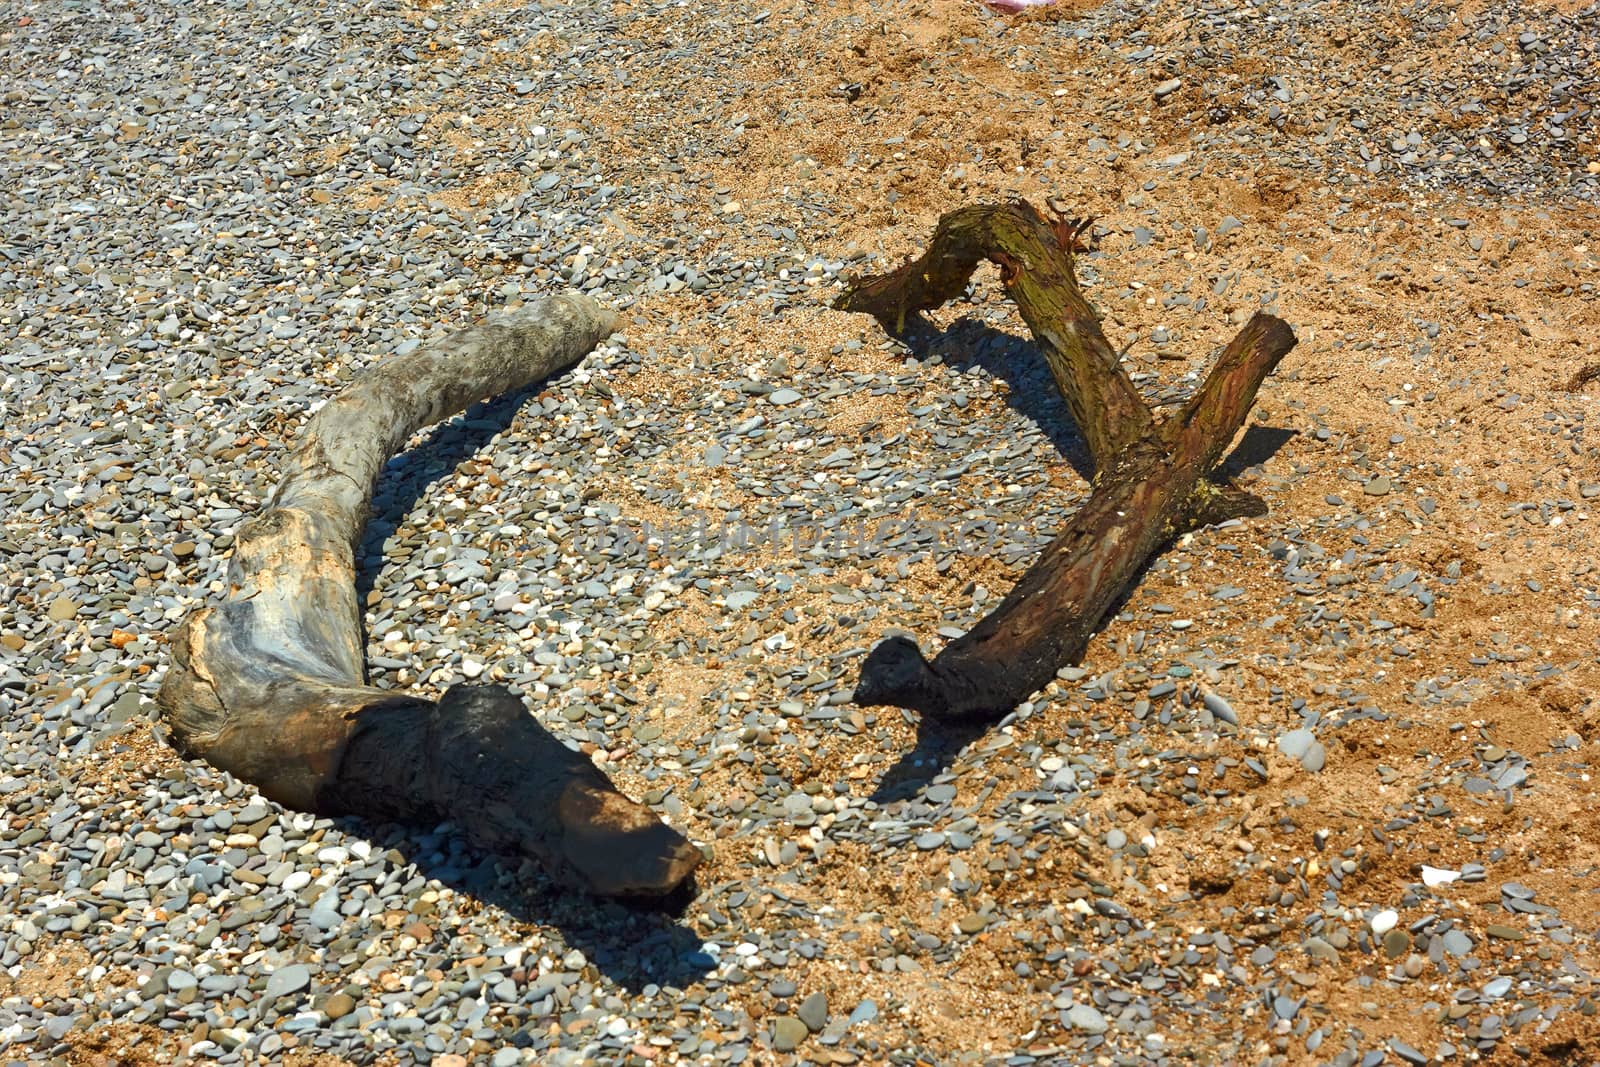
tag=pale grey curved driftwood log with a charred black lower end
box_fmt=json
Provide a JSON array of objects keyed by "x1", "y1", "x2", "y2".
[{"x1": 158, "y1": 296, "x2": 701, "y2": 896}]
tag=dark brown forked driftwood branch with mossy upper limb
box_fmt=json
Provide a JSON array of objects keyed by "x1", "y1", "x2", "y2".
[{"x1": 835, "y1": 202, "x2": 1294, "y2": 721}]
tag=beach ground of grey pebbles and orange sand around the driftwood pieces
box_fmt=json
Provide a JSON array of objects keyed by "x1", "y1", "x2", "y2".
[{"x1": 0, "y1": 0, "x2": 1600, "y2": 1067}]
